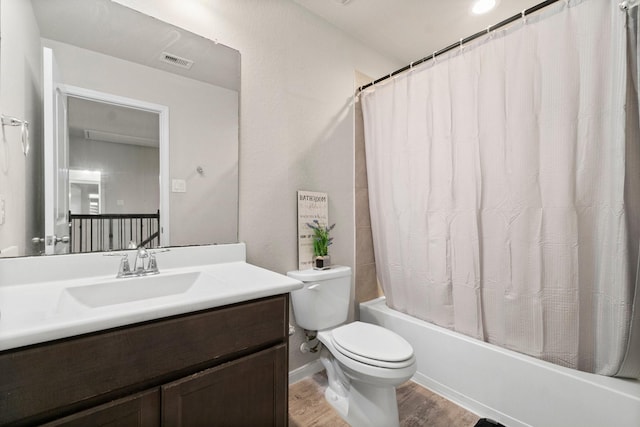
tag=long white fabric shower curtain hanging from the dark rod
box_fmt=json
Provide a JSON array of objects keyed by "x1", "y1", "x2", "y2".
[{"x1": 361, "y1": 0, "x2": 640, "y2": 377}]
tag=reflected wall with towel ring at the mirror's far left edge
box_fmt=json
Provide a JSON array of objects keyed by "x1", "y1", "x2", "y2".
[{"x1": 0, "y1": 0, "x2": 44, "y2": 255}]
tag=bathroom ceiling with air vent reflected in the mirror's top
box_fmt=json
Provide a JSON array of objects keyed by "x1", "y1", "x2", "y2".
[{"x1": 31, "y1": 0, "x2": 240, "y2": 90}]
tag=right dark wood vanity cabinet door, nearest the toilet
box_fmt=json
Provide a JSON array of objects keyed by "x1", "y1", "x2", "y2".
[{"x1": 162, "y1": 344, "x2": 288, "y2": 427}]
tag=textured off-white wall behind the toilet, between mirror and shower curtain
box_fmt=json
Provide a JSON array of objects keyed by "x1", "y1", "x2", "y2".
[{"x1": 116, "y1": 0, "x2": 404, "y2": 369}]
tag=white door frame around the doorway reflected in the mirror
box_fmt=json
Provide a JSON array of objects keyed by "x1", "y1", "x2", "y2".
[{"x1": 60, "y1": 84, "x2": 170, "y2": 246}]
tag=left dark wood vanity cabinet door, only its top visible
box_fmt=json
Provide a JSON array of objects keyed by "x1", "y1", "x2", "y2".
[{"x1": 44, "y1": 389, "x2": 160, "y2": 427}]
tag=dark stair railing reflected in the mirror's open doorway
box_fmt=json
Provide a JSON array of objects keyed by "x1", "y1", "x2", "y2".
[{"x1": 69, "y1": 211, "x2": 160, "y2": 253}]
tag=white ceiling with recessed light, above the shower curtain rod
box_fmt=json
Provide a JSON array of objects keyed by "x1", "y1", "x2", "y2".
[{"x1": 293, "y1": 0, "x2": 541, "y2": 65}]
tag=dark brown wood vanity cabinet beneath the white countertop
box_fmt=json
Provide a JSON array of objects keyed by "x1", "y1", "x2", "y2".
[{"x1": 0, "y1": 295, "x2": 289, "y2": 427}]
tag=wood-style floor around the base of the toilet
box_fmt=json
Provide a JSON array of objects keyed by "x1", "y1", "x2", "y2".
[{"x1": 289, "y1": 373, "x2": 479, "y2": 427}]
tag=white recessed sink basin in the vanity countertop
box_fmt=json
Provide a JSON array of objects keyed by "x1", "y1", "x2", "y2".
[{"x1": 62, "y1": 271, "x2": 215, "y2": 308}]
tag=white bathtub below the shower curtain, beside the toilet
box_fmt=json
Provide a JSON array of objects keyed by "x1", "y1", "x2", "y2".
[{"x1": 360, "y1": 297, "x2": 640, "y2": 427}]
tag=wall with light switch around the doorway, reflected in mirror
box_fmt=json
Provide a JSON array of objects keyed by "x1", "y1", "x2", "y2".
[{"x1": 43, "y1": 39, "x2": 238, "y2": 245}]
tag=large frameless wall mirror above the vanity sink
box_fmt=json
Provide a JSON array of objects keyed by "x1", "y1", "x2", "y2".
[{"x1": 0, "y1": 0, "x2": 240, "y2": 256}]
